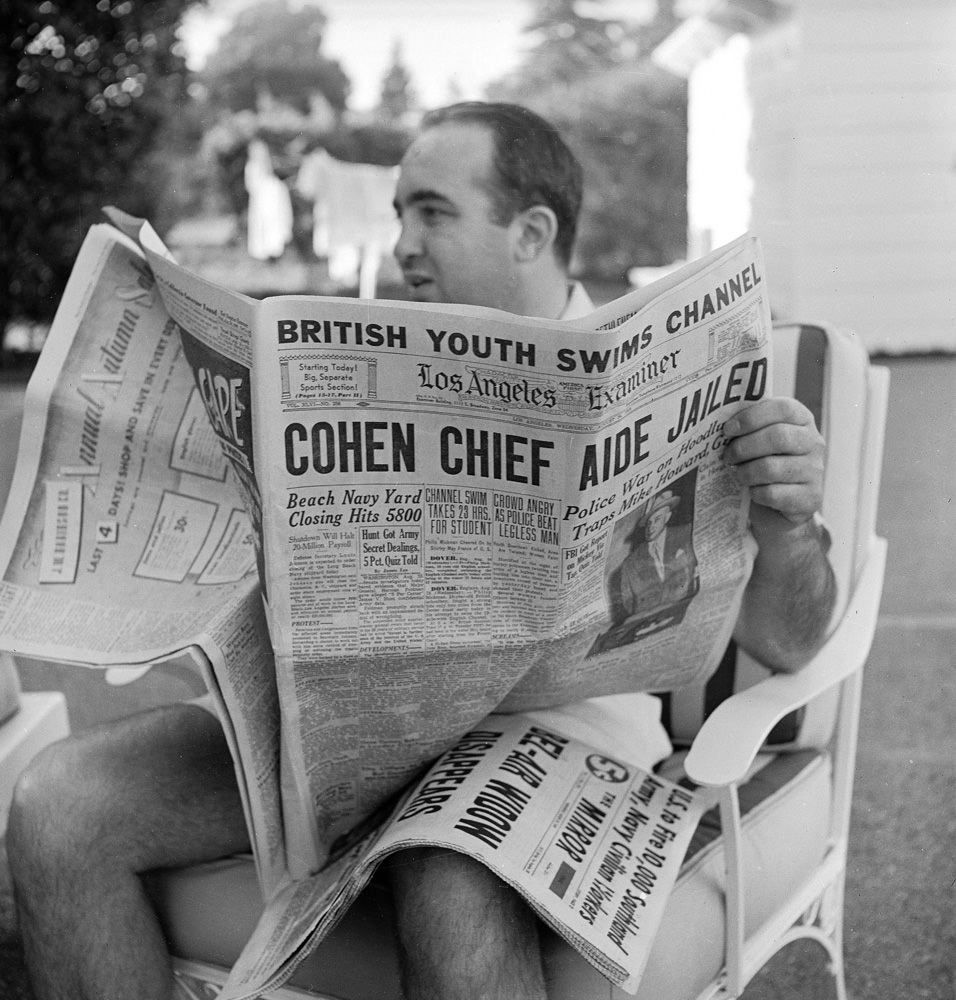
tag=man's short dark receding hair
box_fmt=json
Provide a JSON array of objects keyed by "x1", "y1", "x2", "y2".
[{"x1": 421, "y1": 101, "x2": 583, "y2": 267}]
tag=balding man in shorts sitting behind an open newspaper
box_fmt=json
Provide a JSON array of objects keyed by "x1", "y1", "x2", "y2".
[{"x1": 8, "y1": 104, "x2": 833, "y2": 1000}]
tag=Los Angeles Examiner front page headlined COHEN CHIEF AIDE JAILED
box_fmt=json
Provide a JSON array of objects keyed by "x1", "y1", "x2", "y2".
[{"x1": 246, "y1": 239, "x2": 770, "y2": 875}]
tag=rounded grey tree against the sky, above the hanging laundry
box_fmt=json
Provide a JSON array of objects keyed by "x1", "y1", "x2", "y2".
[{"x1": 201, "y1": 0, "x2": 350, "y2": 115}]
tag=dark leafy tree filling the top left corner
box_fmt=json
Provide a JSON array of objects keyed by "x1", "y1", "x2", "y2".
[{"x1": 0, "y1": 0, "x2": 196, "y2": 333}]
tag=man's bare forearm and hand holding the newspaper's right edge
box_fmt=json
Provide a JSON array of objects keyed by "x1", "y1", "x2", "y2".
[{"x1": 724, "y1": 397, "x2": 836, "y2": 671}]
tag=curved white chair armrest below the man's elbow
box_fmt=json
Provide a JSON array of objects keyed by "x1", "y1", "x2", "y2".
[{"x1": 684, "y1": 538, "x2": 886, "y2": 787}]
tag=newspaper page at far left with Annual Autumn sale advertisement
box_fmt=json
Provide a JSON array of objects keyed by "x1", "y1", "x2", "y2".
[{"x1": 0, "y1": 225, "x2": 256, "y2": 665}]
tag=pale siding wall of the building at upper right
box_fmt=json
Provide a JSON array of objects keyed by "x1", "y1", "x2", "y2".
[{"x1": 749, "y1": 0, "x2": 956, "y2": 352}]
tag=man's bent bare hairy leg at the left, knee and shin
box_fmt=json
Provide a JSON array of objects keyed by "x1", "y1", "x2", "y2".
[{"x1": 7, "y1": 705, "x2": 249, "y2": 1000}]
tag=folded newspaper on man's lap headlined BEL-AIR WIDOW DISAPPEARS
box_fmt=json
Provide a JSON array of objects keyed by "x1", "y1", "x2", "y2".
[{"x1": 215, "y1": 714, "x2": 710, "y2": 1000}]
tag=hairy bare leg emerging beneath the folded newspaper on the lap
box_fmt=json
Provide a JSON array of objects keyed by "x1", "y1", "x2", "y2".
[{"x1": 387, "y1": 848, "x2": 547, "y2": 1000}]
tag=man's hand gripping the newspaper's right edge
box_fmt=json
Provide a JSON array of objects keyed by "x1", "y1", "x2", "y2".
[{"x1": 724, "y1": 396, "x2": 826, "y2": 542}]
